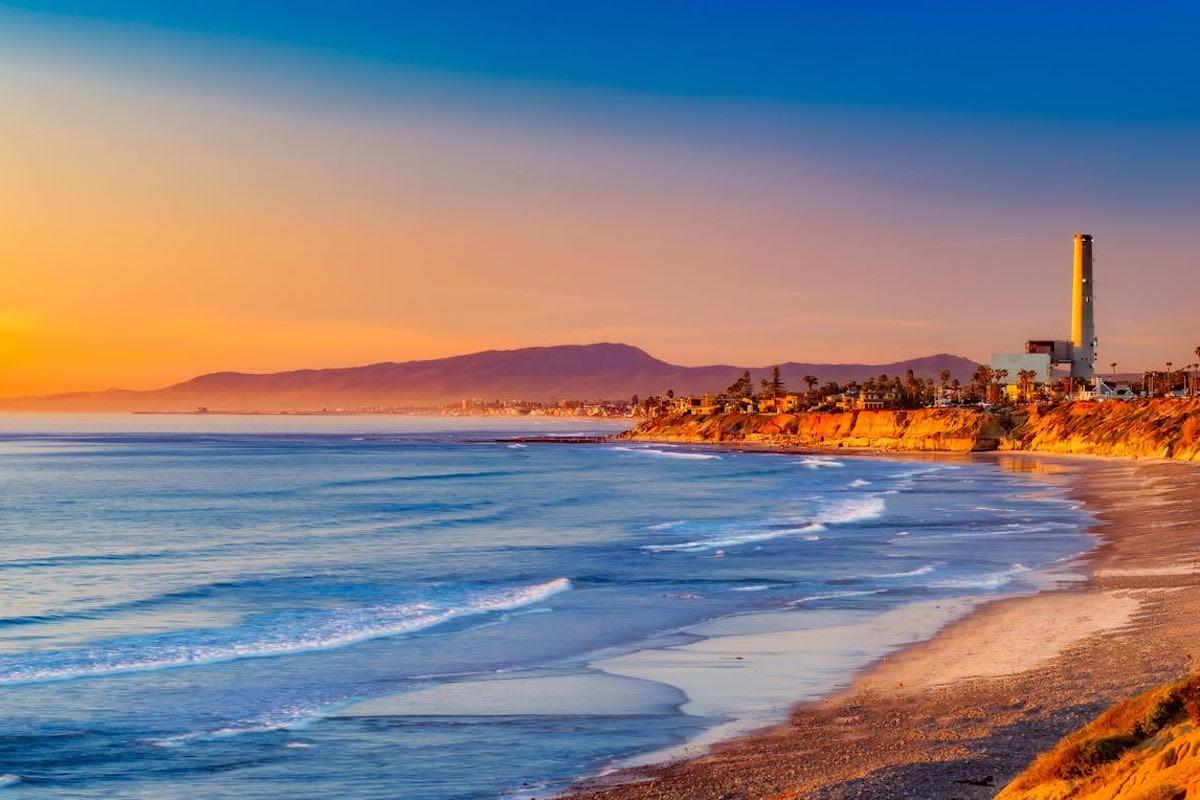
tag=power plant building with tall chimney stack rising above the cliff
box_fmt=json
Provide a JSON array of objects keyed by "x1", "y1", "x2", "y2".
[{"x1": 991, "y1": 234, "x2": 1096, "y2": 385}]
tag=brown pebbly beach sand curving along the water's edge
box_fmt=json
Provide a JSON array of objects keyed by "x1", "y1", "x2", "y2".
[{"x1": 561, "y1": 453, "x2": 1200, "y2": 800}]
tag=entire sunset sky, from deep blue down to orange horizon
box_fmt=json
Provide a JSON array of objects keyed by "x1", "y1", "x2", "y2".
[{"x1": 0, "y1": 0, "x2": 1200, "y2": 396}]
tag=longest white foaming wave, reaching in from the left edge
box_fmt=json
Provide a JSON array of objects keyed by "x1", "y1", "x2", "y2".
[{"x1": 0, "y1": 578, "x2": 571, "y2": 685}]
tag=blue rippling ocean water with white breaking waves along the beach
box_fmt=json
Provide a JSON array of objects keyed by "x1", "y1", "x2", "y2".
[{"x1": 0, "y1": 416, "x2": 1091, "y2": 800}]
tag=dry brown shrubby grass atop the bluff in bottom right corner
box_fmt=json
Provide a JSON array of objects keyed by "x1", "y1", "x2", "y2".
[{"x1": 1014, "y1": 674, "x2": 1200, "y2": 800}]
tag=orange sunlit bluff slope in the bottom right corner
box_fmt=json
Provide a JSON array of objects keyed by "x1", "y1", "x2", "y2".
[{"x1": 996, "y1": 676, "x2": 1200, "y2": 800}]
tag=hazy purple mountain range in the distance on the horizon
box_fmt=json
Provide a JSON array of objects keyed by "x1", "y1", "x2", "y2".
[{"x1": 0, "y1": 343, "x2": 977, "y2": 411}]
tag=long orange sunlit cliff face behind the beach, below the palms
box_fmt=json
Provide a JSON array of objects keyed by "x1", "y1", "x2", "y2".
[{"x1": 623, "y1": 399, "x2": 1200, "y2": 461}]
